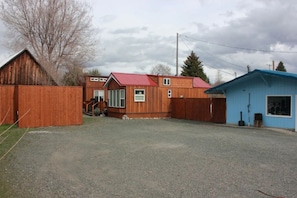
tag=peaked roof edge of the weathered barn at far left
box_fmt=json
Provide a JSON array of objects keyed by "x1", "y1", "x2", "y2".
[{"x1": 0, "y1": 48, "x2": 58, "y2": 85}]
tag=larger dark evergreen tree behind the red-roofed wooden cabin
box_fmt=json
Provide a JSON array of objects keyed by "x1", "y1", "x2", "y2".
[{"x1": 181, "y1": 51, "x2": 209, "y2": 83}]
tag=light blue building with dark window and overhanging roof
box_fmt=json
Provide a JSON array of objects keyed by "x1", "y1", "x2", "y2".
[{"x1": 205, "y1": 70, "x2": 297, "y2": 131}]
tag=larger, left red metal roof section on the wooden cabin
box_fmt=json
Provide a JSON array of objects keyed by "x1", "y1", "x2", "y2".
[{"x1": 111, "y1": 73, "x2": 158, "y2": 86}]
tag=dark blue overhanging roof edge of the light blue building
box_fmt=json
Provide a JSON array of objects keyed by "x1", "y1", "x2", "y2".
[{"x1": 205, "y1": 69, "x2": 297, "y2": 94}]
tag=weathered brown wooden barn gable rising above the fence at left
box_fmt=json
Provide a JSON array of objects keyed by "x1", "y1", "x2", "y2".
[{"x1": 0, "y1": 49, "x2": 57, "y2": 85}]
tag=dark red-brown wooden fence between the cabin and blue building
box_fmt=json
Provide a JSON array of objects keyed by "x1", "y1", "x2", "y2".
[{"x1": 171, "y1": 98, "x2": 226, "y2": 123}]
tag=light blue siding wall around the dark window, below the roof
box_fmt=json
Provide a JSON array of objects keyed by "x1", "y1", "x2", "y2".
[{"x1": 226, "y1": 77, "x2": 297, "y2": 129}]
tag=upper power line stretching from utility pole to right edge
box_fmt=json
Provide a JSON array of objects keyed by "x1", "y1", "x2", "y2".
[{"x1": 180, "y1": 35, "x2": 297, "y2": 54}]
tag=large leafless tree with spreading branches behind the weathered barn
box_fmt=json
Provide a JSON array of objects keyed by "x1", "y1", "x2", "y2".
[{"x1": 0, "y1": 0, "x2": 96, "y2": 84}]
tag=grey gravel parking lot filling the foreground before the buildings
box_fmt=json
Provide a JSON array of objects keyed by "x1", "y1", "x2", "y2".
[{"x1": 0, "y1": 117, "x2": 297, "y2": 198}]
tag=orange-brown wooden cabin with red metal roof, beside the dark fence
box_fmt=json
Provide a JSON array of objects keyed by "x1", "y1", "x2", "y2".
[{"x1": 104, "y1": 73, "x2": 210, "y2": 118}]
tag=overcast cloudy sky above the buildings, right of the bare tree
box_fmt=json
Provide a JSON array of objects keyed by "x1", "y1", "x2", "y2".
[{"x1": 0, "y1": 0, "x2": 297, "y2": 83}]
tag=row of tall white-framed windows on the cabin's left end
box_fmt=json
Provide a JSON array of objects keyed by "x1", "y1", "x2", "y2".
[{"x1": 108, "y1": 89, "x2": 125, "y2": 108}]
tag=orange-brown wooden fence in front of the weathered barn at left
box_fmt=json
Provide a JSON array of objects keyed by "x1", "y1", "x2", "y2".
[{"x1": 0, "y1": 85, "x2": 82, "y2": 128}]
